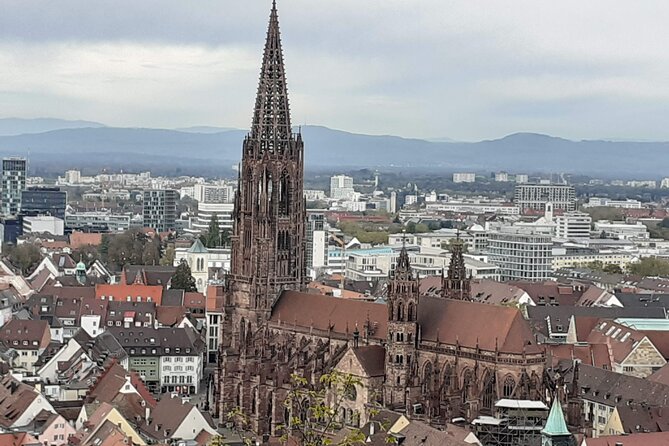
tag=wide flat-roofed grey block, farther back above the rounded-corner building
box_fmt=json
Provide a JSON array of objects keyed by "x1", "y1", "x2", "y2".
[{"x1": 514, "y1": 184, "x2": 576, "y2": 212}]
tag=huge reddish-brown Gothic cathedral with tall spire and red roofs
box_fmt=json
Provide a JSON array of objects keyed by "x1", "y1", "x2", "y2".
[{"x1": 212, "y1": 4, "x2": 545, "y2": 435}]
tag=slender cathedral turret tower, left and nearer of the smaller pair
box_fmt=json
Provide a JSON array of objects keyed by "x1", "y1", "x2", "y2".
[{"x1": 384, "y1": 246, "x2": 420, "y2": 408}]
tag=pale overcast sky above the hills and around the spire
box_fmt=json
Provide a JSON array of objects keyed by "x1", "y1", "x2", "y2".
[{"x1": 0, "y1": 0, "x2": 669, "y2": 140}]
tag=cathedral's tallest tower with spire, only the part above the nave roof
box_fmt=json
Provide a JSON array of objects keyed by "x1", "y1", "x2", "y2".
[{"x1": 228, "y1": 2, "x2": 306, "y2": 320}]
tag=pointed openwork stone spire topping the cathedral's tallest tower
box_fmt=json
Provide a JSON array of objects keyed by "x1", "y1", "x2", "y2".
[{"x1": 250, "y1": 1, "x2": 291, "y2": 153}]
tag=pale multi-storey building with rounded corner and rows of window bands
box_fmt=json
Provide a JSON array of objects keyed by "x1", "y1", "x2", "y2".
[{"x1": 486, "y1": 227, "x2": 553, "y2": 281}]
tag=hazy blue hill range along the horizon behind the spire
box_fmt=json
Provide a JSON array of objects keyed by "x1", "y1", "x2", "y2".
[{"x1": 0, "y1": 120, "x2": 669, "y2": 176}]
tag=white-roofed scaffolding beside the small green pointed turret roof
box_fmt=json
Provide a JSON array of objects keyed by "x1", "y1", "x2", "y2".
[{"x1": 472, "y1": 399, "x2": 549, "y2": 446}]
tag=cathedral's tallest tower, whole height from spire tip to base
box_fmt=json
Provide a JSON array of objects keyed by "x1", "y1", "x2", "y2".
[{"x1": 213, "y1": 2, "x2": 306, "y2": 433}]
